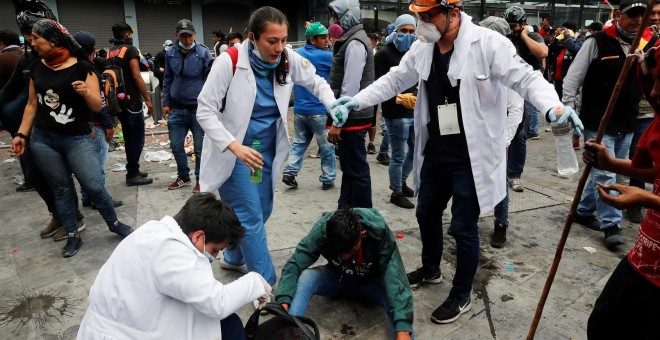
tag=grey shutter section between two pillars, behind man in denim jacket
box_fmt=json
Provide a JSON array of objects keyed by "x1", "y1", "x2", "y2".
[{"x1": 135, "y1": 0, "x2": 191, "y2": 55}]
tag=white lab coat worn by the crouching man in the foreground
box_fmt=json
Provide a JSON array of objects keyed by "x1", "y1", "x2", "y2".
[{"x1": 78, "y1": 216, "x2": 265, "y2": 340}]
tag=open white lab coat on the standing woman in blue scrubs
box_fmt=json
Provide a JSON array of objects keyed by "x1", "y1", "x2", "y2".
[{"x1": 197, "y1": 42, "x2": 335, "y2": 194}]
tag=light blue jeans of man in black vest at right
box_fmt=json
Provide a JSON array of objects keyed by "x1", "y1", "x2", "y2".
[{"x1": 577, "y1": 130, "x2": 633, "y2": 230}]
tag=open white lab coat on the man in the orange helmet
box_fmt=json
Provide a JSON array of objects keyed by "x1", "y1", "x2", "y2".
[{"x1": 355, "y1": 13, "x2": 562, "y2": 212}]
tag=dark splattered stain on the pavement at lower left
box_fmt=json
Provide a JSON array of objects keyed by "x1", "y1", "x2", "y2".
[{"x1": 0, "y1": 291, "x2": 79, "y2": 334}]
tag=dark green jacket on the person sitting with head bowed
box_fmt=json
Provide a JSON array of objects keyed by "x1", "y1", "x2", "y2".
[{"x1": 275, "y1": 208, "x2": 413, "y2": 332}]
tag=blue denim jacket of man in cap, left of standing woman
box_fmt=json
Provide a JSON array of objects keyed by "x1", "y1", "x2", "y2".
[{"x1": 163, "y1": 43, "x2": 212, "y2": 108}]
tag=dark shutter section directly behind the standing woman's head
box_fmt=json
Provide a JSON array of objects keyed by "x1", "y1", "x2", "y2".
[{"x1": 197, "y1": 2, "x2": 250, "y2": 45}]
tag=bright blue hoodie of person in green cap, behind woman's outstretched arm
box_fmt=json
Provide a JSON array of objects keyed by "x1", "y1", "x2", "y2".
[{"x1": 293, "y1": 44, "x2": 332, "y2": 115}]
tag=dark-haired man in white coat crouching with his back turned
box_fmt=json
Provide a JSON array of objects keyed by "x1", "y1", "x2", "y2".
[{"x1": 78, "y1": 193, "x2": 271, "y2": 340}]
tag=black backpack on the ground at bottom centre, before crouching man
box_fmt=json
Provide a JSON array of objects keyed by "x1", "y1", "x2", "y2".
[{"x1": 245, "y1": 303, "x2": 321, "y2": 340}]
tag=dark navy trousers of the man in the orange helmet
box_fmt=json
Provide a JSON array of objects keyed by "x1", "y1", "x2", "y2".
[{"x1": 416, "y1": 156, "x2": 480, "y2": 299}]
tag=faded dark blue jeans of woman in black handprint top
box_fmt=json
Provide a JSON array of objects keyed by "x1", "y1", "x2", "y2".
[{"x1": 30, "y1": 128, "x2": 117, "y2": 233}]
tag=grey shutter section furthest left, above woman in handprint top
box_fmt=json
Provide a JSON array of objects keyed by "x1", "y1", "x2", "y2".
[{"x1": 57, "y1": 0, "x2": 124, "y2": 49}]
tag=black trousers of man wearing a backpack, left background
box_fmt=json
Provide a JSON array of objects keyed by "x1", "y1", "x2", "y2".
[{"x1": 117, "y1": 102, "x2": 144, "y2": 178}]
